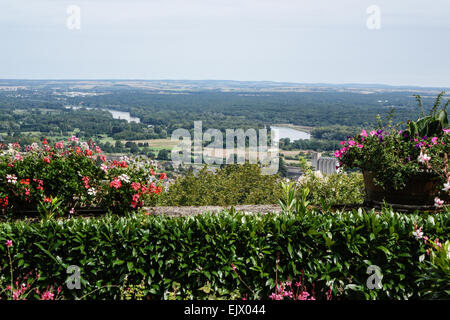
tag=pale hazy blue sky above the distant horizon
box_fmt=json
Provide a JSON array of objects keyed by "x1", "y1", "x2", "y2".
[{"x1": 0, "y1": 0, "x2": 450, "y2": 87}]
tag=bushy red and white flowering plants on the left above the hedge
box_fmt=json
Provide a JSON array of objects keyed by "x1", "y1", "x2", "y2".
[{"x1": 0, "y1": 136, "x2": 165, "y2": 214}]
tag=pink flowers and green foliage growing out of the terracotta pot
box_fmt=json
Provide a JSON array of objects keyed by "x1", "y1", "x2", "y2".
[{"x1": 335, "y1": 93, "x2": 450, "y2": 206}]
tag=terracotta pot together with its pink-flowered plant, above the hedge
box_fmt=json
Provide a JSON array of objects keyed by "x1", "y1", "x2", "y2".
[{"x1": 335, "y1": 92, "x2": 450, "y2": 207}]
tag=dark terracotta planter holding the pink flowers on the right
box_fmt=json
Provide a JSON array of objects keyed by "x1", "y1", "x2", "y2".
[{"x1": 363, "y1": 171, "x2": 442, "y2": 206}]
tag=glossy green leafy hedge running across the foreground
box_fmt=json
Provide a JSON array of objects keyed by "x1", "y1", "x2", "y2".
[{"x1": 0, "y1": 210, "x2": 450, "y2": 299}]
